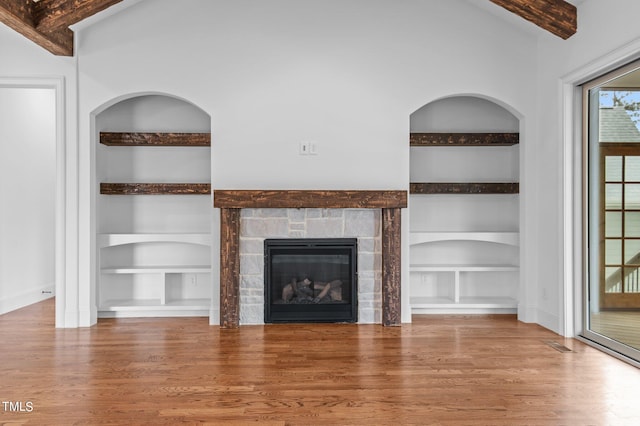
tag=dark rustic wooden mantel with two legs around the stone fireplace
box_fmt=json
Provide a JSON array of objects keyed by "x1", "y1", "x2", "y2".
[{"x1": 214, "y1": 190, "x2": 407, "y2": 328}]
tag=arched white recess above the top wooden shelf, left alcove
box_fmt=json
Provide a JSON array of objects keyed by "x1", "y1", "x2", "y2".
[{"x1": 96, "y1": 94, "x2": 211, "y2": 133}]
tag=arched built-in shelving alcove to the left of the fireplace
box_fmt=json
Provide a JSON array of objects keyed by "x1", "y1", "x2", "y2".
[{"x1": 95, "y1": 95, "x2": 212, "y2": 317}]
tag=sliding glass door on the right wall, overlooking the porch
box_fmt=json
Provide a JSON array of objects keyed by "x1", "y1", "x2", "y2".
[{"x1": 582, "y1": 63, "x2": 640, "y2": 361}]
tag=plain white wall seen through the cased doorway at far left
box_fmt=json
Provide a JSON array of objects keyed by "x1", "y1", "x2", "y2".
[{"x1": 0, "y1": 87, "x2": 56, "y2": 314}]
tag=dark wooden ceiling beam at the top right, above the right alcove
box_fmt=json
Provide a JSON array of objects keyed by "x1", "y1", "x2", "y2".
[{"x1": 489, "y1": 0, "x2": 578, "y2": 40}]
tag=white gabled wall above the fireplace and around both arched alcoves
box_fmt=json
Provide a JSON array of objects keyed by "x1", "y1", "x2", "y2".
[{"x1": 78, "y1": 0, "x2": 537, "y2": 325}]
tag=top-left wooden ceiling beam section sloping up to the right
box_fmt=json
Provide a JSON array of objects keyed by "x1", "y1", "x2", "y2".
[{"x1": 33, "y1": 0, "x2": 122, "y2": 33}]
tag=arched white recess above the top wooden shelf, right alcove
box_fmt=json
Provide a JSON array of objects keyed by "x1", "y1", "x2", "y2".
[{"x1": 410, "y1": 95, "x2": 520, "y2": 133}]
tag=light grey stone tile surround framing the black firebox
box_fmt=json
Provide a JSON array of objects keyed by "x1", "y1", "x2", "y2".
[{"x1": 248, "y1": 209, "x2": 372, "y2": 325}]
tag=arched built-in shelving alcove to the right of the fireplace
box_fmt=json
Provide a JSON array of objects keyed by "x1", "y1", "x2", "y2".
[{"x1": 409, "y1": 96, "x2": 520, "y2": 313}]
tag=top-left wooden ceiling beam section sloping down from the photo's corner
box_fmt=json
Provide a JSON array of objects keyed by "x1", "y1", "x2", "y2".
[{"x1": 0, "y1": 0, "x2": 73, "y2": 56}]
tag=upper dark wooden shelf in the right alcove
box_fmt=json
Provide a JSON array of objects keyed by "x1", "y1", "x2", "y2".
[{"x1": 409, "y1": 133, "x2": 520, "y2": 146}]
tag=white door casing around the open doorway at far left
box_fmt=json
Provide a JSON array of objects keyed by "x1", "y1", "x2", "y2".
[{"x1": 0, "y1": 77, "x2": 67, "y2": 327}]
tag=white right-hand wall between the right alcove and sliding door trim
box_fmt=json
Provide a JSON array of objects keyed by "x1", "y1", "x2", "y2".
[{"x1": 532, "y1": 0, "x2": 640, "y2": 335}]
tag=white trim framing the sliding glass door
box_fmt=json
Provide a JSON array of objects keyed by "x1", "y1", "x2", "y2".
[{"x1": 560, "y1": 39, "x2": 640, "y2": 337}]
